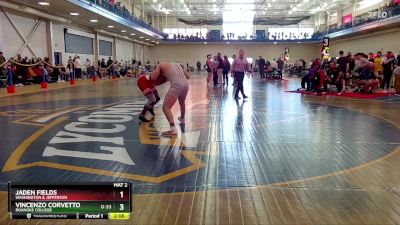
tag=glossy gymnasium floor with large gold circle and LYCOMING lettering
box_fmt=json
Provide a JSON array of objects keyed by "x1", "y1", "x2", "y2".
[{"x1": 0, "y1": 75, "x2": 400, "y2": 225}]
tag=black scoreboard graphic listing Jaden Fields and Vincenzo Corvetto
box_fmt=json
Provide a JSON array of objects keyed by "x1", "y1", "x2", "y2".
[{"x1": 8, "y1": 182, "x2": 132, "y2": 219}]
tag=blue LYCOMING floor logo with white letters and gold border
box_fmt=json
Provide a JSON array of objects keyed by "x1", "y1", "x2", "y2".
[{"x1": 0, "y1": 100, "x2": 206, "y2": 183}]
